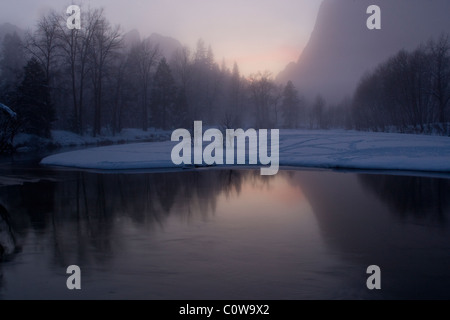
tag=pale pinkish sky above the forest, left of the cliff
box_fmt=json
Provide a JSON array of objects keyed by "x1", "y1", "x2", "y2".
[{"x1": 0, "y1": 0, "x2": 321, "y2": 76}]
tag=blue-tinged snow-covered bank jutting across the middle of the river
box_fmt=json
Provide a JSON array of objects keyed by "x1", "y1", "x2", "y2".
[{"x1": 41, "y1": 130, "x2": 450, "y2": 172}]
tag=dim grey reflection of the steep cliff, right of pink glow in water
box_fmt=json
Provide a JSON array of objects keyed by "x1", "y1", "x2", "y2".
[{"x1": 291, "y1": 171, "x2": 383, "y2": 252}]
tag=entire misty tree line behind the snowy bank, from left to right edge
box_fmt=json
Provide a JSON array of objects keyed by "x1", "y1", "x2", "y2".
[{"x1": 0, "y1": 4, "x2": 450, "y2": 155}]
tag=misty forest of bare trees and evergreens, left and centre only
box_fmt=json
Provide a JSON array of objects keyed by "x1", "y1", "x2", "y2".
[{"x1": 0, "y1": 9, "x2": 304, "y2": 152}]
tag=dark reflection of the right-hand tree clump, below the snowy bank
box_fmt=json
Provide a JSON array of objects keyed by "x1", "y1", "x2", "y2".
[{"x1": 358, "y1": 175, "x2": 450, "y2": 224}]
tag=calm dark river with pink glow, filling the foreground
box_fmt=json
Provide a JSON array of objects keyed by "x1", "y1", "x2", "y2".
[{"x1": 0, "y1": 161, "x2": 450, "y2": 300}]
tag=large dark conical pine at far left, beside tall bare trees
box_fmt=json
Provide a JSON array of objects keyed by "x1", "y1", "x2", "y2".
[{"x1": 15, "y1": 58, "x2": 55, "y2": 138}]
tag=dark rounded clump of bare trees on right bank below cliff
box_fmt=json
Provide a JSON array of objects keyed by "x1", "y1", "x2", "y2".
[{"x1": 351, "y1": 35, "x2": 450, "y2": 135}]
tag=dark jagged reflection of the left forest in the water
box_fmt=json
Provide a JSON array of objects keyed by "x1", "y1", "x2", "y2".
[{"x1": 0, "y1": 170, "x2": 268, "y2": 266}]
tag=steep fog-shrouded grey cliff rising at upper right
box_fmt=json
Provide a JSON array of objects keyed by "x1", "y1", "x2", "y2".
[{"x1": 278, "y1": 0, "x2": 450, "y2": 103}]
